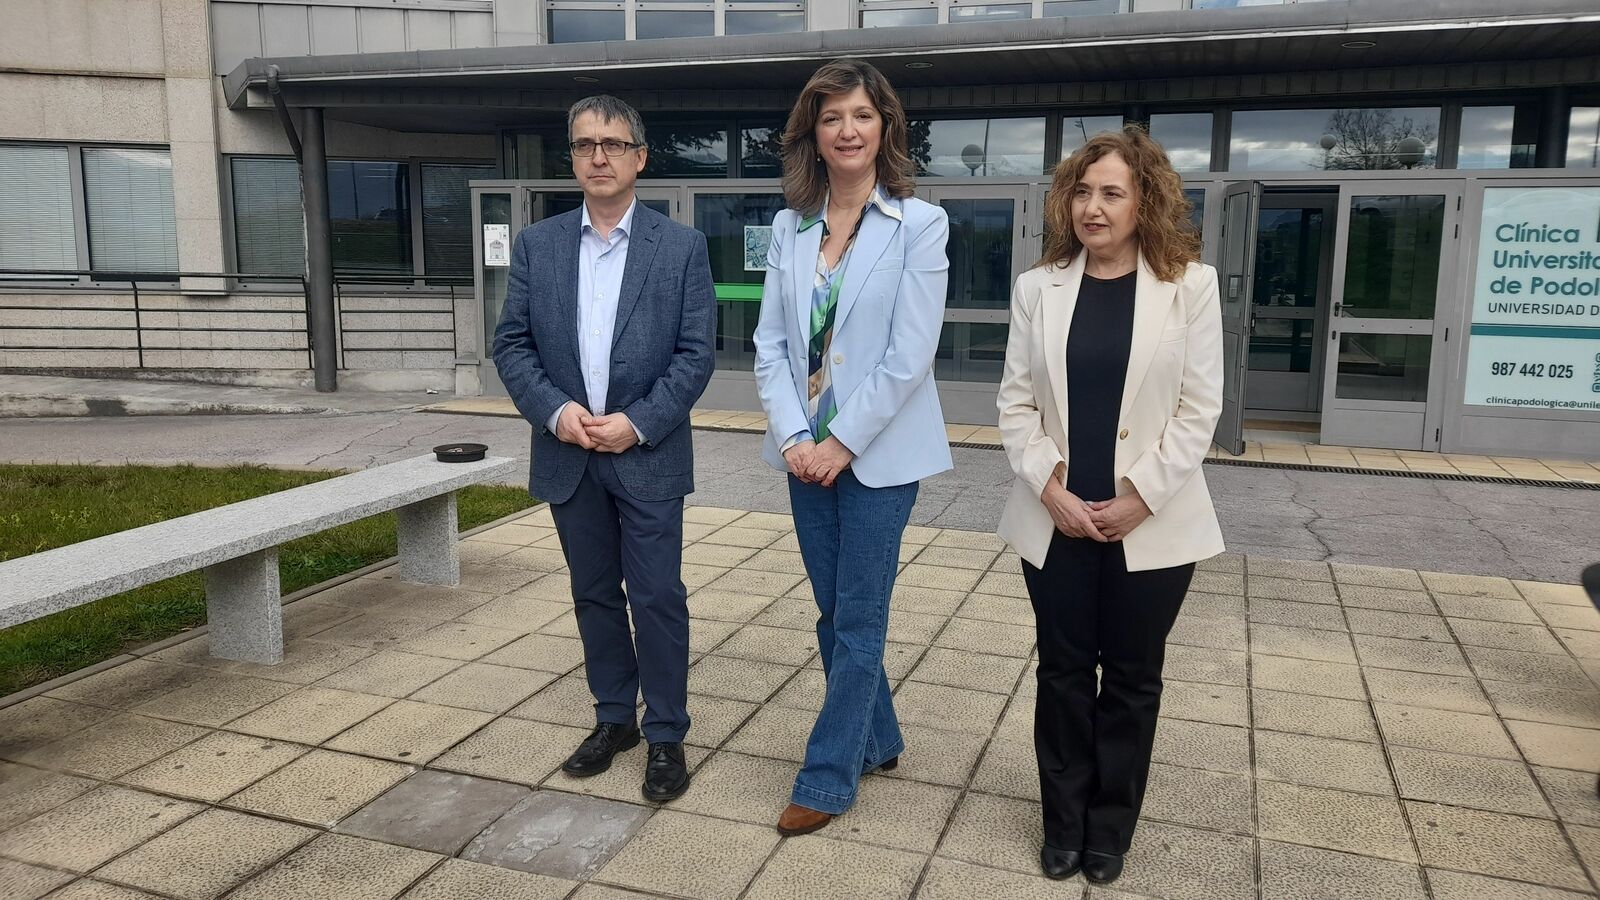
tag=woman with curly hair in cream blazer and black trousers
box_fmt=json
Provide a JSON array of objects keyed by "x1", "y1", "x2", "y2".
[{"x1": 998, "y1": 127, "x2": 1222, "y2": 884}]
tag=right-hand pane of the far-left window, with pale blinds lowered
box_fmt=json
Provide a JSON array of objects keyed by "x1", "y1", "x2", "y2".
[{"x1": 83, "y1": 149, "x2": 178, "y2": 272}]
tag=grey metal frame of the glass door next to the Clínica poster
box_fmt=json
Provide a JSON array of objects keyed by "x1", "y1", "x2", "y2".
[{"x1": 1322, "y1": 178, "x2": 1466, "y2": 450}]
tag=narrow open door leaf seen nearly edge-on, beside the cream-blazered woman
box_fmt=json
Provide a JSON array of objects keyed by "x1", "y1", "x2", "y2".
[{"x1": 1213, "y1": 181, "x2": 1261, "y2": 456}]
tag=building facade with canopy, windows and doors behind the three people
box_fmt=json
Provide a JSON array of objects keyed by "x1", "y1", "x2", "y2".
[{"x1": 0, "y1": 0, "x2": 1600, "y2": 455}]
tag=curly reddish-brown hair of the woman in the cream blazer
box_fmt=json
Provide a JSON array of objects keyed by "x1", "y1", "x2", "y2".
[{"x1": 1038, "y1": 125, "x2": 1200, "y2": 282}]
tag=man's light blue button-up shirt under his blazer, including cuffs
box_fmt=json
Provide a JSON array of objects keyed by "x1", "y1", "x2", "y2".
[{"x1": 546, "y1": 197, "x2": 645, "y2": 444}]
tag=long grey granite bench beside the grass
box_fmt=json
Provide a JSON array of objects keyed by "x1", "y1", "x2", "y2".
[{"x1": 0, "y1": 456, "x2": 522, "y2": 665}]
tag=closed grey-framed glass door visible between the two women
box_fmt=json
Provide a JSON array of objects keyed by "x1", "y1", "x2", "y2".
[{"x1": 926, "y1": 184, "x2": 1032, "y2": 421}]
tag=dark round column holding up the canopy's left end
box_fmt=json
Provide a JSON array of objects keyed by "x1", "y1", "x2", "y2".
[{"x1": 301, "y1": 109, "x2": 339, "y2": 394}]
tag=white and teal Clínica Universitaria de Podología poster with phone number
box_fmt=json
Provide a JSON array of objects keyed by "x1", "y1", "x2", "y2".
[{"x1": 1466, "y1": 186, "x2": 1600, "y2": 410}]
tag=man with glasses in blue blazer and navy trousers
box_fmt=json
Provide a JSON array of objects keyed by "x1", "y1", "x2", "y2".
[{"x1": 494, "y1": 96, "x2": 717, "y2": 802}]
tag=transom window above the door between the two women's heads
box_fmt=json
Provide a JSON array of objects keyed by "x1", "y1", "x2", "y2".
[{"x1": 907, "y1": 119, "x2": 1046, "y2": 178}]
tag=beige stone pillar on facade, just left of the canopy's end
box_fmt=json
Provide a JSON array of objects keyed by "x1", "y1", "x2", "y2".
[{"x1": 162, "y1": 0, "x2": 229, "y2": 293}]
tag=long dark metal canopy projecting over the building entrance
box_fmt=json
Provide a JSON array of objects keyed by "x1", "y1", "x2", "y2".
[{"x1": 224, "y1": 0, "x2": 1600, "y2": 130}]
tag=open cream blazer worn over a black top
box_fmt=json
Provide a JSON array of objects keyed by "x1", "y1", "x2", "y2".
[{"x1": 998, "y1": 253, "x2": 1222, "y2": 572}]
